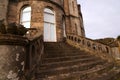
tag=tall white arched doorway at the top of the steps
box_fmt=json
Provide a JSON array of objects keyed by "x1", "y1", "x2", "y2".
[{"x1": 44, "y1": 8, "x2": 57, "y2": 42}]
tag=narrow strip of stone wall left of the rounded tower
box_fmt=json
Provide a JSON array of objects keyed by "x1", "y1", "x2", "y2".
[{"x1": 0, "y1": 0, "x2": 8, "y2": 21}]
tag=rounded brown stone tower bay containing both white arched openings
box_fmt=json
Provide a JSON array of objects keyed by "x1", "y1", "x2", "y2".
[{"x1": 8, "y1": 0, "x2": 65, "y2": 42}]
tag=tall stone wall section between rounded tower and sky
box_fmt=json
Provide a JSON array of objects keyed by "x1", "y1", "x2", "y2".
[{"x1": 64, "y1": 0, "x2": 85, "y2": 36}]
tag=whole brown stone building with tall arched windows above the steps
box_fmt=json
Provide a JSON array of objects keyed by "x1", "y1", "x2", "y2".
[{"x1": 0, "y1": 0, "x2": 85, "y2": 42}]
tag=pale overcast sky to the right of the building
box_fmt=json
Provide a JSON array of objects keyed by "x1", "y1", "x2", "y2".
[{"x1": 78, "y1": 0, "x2": 120, "y2": 39}]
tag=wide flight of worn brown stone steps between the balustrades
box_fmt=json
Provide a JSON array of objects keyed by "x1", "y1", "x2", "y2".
[{"x1": 36, "y1": 43, "x2": 120, "y2": 80}]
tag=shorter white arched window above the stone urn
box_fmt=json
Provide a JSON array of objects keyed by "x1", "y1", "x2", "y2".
[{"x1": 20, "y1": 6, "x2": 31, "y2": 28}]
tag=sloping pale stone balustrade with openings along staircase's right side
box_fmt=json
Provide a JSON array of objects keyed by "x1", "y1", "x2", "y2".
[{"x1": 67, "y1": 34, "x2": 114, "y2": 62}]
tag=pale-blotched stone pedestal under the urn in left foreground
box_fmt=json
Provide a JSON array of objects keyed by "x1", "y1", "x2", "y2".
[{"x1": 0, "y1": 35, "x2": 28, "y2": 80}]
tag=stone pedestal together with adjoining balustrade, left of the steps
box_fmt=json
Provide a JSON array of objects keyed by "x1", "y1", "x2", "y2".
[{"x1": 0, "y1": 30, "x2": 44, "y2": 80}]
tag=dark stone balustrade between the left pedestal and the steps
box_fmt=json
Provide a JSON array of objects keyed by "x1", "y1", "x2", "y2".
[{"x1": 25, "y1": 29, "x2": 44, "y2": 77}]
